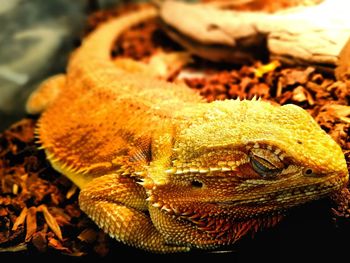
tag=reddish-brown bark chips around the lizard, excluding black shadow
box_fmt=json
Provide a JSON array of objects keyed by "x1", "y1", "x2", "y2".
[{"x1": 0, "y1": 3, "x2": 350, "y2": 256}]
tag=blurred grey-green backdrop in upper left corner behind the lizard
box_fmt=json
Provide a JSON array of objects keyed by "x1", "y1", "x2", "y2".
[{"x1": 0, "y1": 0, "x2": 121, "y2": 132}]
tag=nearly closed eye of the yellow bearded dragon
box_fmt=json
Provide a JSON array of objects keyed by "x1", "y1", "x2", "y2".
[{"x1": 249, "y1": 149, "x2": 284, "y2": 178}]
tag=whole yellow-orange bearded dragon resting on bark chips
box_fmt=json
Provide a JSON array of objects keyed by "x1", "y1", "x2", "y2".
[{"x1": 27, "y1": 5, "x2": 348, "y2": 253}]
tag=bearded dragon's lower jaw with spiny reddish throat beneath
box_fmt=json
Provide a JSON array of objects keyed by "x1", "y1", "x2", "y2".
[{"x1": 149, "y1": 171, "x2": 347, "y2": 249}]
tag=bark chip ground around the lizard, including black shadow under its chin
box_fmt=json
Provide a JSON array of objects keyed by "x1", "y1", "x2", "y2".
[{"x1": 0, "y1": 2, "x2": 350, "y2": 262}]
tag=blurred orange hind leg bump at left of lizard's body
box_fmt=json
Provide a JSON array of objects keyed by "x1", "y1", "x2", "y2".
[{"x1": 26, "y1": 74, "x2": 66, "y2": 114}]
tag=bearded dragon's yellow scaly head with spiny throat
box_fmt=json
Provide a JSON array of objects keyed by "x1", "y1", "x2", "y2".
[{"x1": 148, "y1": 100, "x2": 348, "y2": 250}]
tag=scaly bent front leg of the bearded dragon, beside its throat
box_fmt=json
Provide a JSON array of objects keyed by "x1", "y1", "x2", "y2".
[{"x1": 79, "y1": 174, "x2": 189, "y2": 253}]
